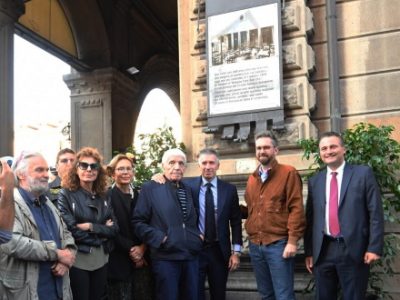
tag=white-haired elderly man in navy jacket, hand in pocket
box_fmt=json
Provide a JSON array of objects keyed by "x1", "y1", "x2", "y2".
[{"x1": 133, "y1": 148, "x2": 203, "y2": 300}]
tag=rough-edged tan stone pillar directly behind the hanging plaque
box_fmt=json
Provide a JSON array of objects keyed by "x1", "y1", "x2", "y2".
[{"x1": 179, "y1": 0, "x2": 317, "y2": 162}]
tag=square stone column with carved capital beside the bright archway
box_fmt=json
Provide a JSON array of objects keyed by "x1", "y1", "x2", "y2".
[{"x1": 64, "y1": 68, "x2": 138, "y2": 162}]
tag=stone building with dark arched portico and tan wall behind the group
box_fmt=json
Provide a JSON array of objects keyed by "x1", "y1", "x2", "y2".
[{"x1": 0, "y1": 0, "x2": 400, "y2": 298}]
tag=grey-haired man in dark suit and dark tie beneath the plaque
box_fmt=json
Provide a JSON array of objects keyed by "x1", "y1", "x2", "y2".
[{"x1": 184, "y1": 148, "x2": 242, "y2": 300}]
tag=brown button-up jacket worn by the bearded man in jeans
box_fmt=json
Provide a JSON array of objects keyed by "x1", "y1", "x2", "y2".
[{"x1": 245, "y1": 160, "x2": 306, "y2": 245}]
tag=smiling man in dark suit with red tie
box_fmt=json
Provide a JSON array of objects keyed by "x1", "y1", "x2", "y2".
[{"x1": 304, "y1": 132, "x2": 384, "y2": 300}]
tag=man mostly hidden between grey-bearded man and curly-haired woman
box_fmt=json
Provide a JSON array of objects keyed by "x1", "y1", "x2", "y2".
[{"x1": 47, "y1": 148, "x2": 76, "y2": 207}]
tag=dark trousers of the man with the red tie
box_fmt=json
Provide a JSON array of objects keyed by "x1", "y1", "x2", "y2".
[{"x1": 314, "y1": 237, "x2": 369, "y2": 300}]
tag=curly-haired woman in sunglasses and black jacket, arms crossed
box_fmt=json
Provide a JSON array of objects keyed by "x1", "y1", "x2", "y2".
[{"x1": 58, "y1": 147, "x2": 118, "y2": 300}]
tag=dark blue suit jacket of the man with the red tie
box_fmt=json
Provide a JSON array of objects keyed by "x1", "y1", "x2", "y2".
[{"x1": 304, "y1": 163, "x2": 384, "y2": 264}]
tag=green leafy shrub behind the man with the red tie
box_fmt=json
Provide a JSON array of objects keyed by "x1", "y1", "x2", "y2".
[{"x1": 299, "y1": 123, "x2": 400, "y2": 297}]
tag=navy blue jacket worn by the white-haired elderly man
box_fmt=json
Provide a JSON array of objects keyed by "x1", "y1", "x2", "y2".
[{"x1": 132, "y1": 181, "x2": 202, "y2": 260}]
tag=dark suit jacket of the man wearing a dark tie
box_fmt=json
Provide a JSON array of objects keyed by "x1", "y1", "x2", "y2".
[{"x1": 183, "y1": 176, "x2": 242, "y2": 260}]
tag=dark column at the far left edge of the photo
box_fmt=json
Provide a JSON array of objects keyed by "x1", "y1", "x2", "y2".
[{"x1": 0, "y1": 0, "x2": 25, "y2": 156}]
